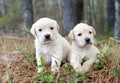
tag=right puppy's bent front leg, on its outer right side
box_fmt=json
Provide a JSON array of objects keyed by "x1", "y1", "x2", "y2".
[{"x1": 82, "y1": 58, "x2": 95, "y2": 72}]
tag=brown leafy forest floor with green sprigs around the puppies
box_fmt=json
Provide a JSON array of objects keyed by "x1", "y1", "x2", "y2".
[{"x1": 0, "y1": 35, "x2": 120, "y2": 83}]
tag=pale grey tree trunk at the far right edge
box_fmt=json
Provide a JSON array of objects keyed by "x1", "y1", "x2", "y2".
[{"x1": 114, "y1": 0, "x2": 120, "y2": 40}]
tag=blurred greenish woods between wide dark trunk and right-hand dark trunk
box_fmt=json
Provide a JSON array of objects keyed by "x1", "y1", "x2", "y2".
[{"x1": 84, "y1": 0, "x2": 109, "y2": 34}]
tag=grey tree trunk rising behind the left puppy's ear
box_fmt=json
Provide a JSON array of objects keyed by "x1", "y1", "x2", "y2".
[{"x1": 23, "y1": 0, "x2": 33, "y2": 29}]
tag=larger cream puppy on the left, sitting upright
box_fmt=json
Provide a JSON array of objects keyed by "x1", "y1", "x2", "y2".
[{"x1": 30, "y1": 18, "x2": 70, "y2": 72}]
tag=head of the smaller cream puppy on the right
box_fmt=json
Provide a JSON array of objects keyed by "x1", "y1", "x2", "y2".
[{"x1": 69, "y1": 23, "x2": 96, "y2": 47}]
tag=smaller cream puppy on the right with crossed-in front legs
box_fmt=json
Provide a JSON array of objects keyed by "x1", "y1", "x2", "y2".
[{"x1": 68, "y1": 23, "x2": 99, "y2": 72}]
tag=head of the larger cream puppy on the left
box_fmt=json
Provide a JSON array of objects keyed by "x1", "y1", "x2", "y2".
[{"x1": 30, "y1": 18, "x2": 59, "y2": 43}]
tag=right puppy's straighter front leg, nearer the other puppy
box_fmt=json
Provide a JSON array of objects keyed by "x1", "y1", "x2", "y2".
[{"x1": 70, "y1": 54, "x2": 82, "y2": 72}]
